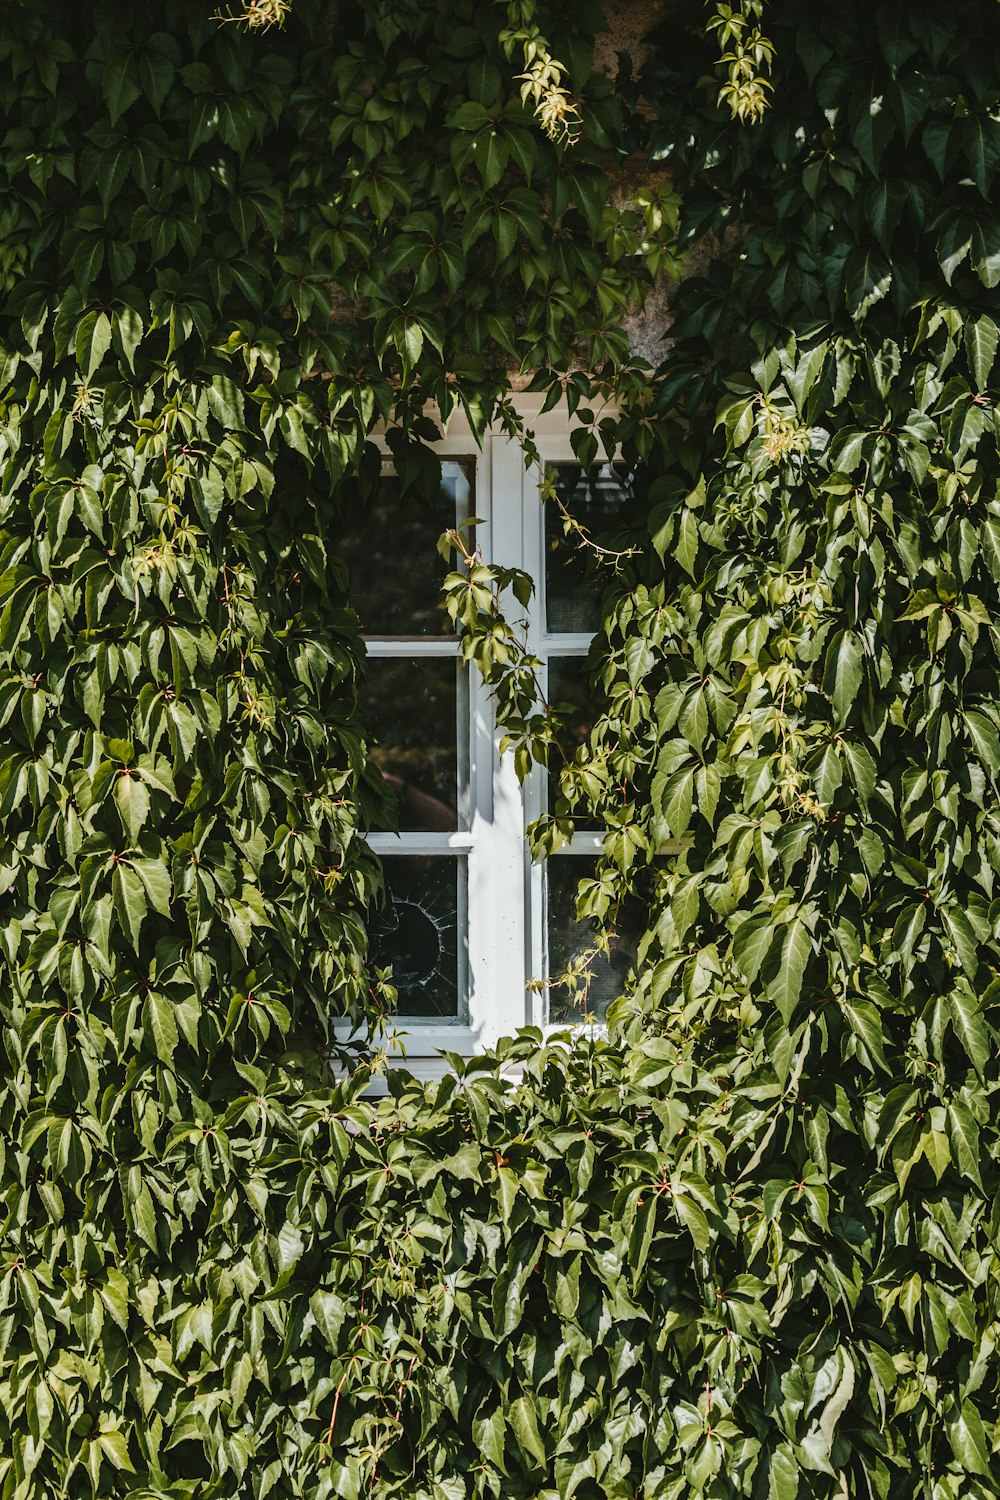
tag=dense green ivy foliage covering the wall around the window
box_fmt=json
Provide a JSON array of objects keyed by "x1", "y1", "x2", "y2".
[{"x1": 0, "y1": 0, "x2": 1000, "y2": 1500}]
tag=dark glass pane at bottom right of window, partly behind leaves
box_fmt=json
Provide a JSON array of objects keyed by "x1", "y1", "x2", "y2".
[{"x1": 546, "y1": 855, "x2": 640, "y2": 1026}]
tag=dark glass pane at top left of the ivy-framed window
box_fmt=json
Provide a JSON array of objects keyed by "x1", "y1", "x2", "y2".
[{"x1": 337, "y1": 461, "x2": 474, "y2": 638}]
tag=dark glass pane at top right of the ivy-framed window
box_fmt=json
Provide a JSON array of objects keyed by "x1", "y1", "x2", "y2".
[{"x1": 546, "y1": 464, "x2": 627, "y2": 630}]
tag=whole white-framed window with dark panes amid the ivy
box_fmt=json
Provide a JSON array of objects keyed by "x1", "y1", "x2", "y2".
[{"x1": 342, "y1": 402, "x2": 630, "y2": 1076}]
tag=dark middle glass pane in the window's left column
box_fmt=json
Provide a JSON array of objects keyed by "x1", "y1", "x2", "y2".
[{"x1": 361, "y1": 657, "x2": 469, "y2": 833}]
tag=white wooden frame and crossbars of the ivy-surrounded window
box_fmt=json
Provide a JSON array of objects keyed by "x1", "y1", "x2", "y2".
[{"x1": 336, "y1": 396, "x2": 603, "y2": 1079}]
